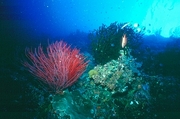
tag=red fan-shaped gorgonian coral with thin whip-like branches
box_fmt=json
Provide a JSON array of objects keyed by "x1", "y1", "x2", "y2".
[{"x1": 23, "y1": 41, "x2": 88, "y2": 93}]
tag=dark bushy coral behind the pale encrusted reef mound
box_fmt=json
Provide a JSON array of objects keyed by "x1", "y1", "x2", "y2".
[{"x1": 89, "y1": 22, "x2": 143, "y2": 65}]
